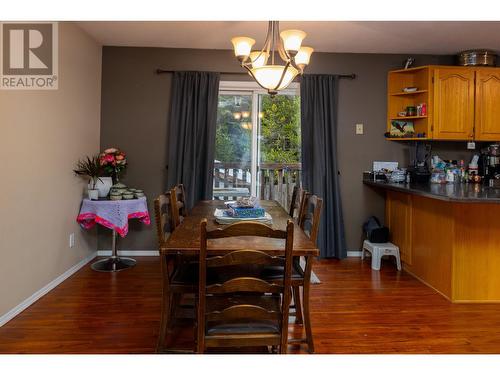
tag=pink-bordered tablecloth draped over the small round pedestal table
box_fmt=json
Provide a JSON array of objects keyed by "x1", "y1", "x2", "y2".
[{"x1": 76, "y1": 198, "x2": 151, "y2": 237}]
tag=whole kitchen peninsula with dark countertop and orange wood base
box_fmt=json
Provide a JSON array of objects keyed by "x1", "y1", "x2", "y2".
[{"x1": 363, "y1": 180, "x2": 500, "y2": 303}]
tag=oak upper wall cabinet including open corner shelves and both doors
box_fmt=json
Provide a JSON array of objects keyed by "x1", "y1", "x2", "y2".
[{"x1": 387, "y1": 66, "x2": 500, "y2": 141}]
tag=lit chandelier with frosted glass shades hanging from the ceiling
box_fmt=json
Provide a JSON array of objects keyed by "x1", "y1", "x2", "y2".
[{"x1": 231, "y1": 21, "x2": 314, "y2": 96}]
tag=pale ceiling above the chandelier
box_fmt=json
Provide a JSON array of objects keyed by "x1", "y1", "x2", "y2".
[{"x1": 78, "y1": 21, "x2": 500, "y2": 55}]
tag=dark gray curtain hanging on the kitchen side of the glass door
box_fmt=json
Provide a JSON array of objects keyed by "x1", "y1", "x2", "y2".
[{"x1": 300, "y1": 74, "x2": 347, "y2": 258}]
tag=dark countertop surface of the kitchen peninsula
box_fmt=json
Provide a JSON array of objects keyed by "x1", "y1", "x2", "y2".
[{"x1": 363, "y1": 179, "x2": 500, "y2": 204}]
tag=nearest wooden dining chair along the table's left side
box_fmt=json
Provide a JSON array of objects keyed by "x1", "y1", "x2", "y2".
[{"x1": 154, "y1": 192, "x2": 198, "y2": 352}]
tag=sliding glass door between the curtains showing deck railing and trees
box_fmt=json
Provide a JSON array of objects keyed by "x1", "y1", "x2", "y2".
[{"x1": 214, "y1": 82, "x2": 300, "y2": 209}]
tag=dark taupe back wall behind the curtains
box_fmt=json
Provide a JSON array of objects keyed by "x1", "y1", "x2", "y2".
[{"x1": 98, "y1": 47, "x2": 454, "y2": 250}]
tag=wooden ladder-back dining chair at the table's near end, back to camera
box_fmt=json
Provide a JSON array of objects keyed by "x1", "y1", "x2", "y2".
[{"x1": 197, "y1": 219, "x2": 293, "y2": 353}]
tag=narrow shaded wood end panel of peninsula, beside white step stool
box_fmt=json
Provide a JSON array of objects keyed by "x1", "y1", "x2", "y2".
[{"x1": 385, "y1": 191, "x2": 412, "y2": 265}]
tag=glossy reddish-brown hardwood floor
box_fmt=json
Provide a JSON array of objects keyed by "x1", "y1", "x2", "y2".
[{"x1": 0, "y1": 257, "x2": 500, "y2": 353}]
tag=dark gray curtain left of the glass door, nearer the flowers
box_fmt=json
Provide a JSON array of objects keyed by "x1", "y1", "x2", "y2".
[{"x1": 167, "y1": 72, "x2": 220, "y2": 208}]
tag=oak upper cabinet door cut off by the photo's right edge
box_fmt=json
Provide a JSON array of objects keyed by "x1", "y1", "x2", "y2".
[{"x1": 475, "y1": 69, "x2": 500, "y2": 141}]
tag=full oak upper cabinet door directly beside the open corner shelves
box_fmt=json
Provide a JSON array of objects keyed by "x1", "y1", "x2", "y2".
[{"x1": 434, "y1": 68, "x2": 475, "y2": 140}]
